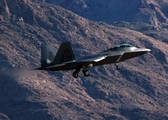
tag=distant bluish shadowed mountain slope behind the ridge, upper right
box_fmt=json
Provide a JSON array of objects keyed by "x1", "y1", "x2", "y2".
[{"x1": 44, "y1": 0, "x2": 168, "y2": 27}]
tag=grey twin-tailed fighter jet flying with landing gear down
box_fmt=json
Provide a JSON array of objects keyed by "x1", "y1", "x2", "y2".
[{"x1": 36, "y1": 42, "x2": 151, "y2": 78}]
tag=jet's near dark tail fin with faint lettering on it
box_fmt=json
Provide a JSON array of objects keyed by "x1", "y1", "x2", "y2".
[{"x1": 53, "y1": 42, "x2": 75, "y2": 64}]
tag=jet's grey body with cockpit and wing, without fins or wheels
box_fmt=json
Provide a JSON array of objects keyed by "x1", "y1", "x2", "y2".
[{"x1": 41, "y1": 44, "x2": 150, "y2": 71}]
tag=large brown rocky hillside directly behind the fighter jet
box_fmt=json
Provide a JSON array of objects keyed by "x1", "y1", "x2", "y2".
[{"x1": 0, "y1": 0, "x2": 168, "y2": 120}]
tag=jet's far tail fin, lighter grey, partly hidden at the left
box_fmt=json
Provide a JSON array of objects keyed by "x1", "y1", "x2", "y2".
[{"x1": 41, "y1": 45, "x2": 56, "y2": 67}]
